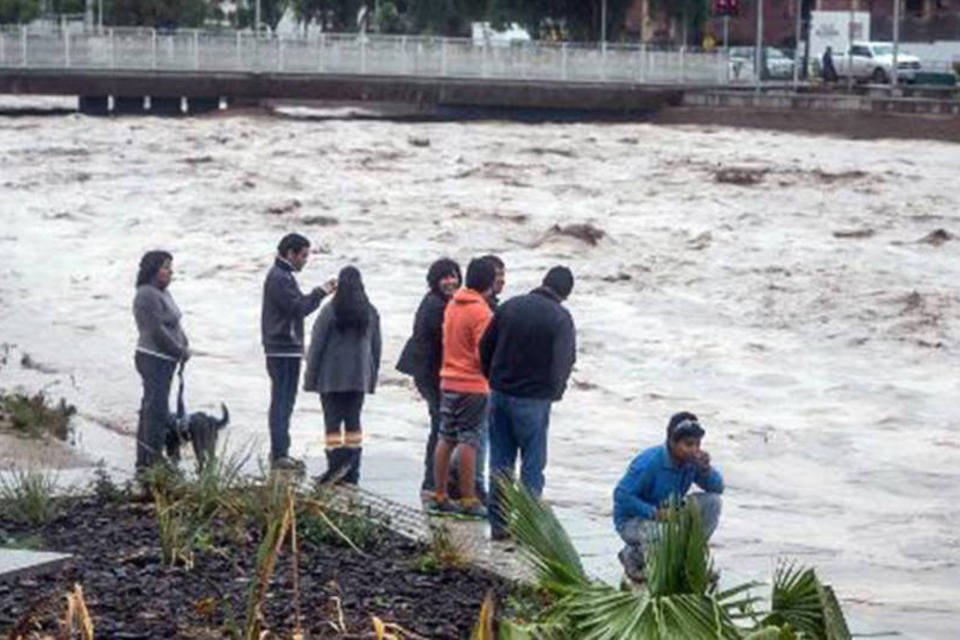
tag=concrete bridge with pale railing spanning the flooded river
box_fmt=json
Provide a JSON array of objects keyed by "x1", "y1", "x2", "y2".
[{"x1": 0, "y1": 28, "x2": 716, "y2": 116}]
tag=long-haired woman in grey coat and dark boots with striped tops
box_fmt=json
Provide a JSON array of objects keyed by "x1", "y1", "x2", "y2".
[{"x1": 303, "y1": 267, "x2": 381, "y2": 484}]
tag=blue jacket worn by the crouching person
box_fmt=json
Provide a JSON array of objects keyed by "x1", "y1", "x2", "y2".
[{"x1": 613, "y1": 444, "x2": 723, "y2": 531}]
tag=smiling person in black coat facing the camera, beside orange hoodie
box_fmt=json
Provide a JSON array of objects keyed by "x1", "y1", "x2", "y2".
[{"x1": 397, "y1": 258, "x2": 463, "y2": 500}]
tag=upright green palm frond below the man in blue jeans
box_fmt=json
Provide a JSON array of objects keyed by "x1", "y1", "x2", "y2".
[{"x1": 497, "y1": 478, "x2": 589, "y2": 593}]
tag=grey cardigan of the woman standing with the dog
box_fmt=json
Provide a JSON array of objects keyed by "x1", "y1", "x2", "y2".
[{"x1": 133, "y1": 284, "x2": 189, "y2": 360}]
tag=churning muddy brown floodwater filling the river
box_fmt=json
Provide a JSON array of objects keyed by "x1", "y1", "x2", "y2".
[{"x1": 0, "y1": 104, "x2": 960, "y2": 638}]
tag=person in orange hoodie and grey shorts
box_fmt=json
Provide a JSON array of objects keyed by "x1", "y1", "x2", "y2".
[{"x1": 427, "y1": 258, "x2": 496, "y2": 518}]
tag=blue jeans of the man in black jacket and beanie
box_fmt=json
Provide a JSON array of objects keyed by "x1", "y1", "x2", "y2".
[{"x1": 489, "y1": 391, "x2": 552, "y2": 534}]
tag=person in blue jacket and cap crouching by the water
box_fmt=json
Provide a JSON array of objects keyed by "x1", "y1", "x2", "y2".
[{"x1": 613, "y1": 411, "x2": 723, "y2": 582}]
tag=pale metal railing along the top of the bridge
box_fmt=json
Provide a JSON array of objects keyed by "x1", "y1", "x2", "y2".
[{"x1": 0, "y1": 27, "x2": 730, "y2": 84}]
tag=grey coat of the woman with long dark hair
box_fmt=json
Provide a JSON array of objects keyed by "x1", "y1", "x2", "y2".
[{"x1": 303, "y1": 304, "x2": 381, "y2": 393}]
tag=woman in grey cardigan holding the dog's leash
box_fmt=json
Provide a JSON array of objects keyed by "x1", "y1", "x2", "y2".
[{"x1": 133, "y1": 251, "x2": 190, "y2": 471}]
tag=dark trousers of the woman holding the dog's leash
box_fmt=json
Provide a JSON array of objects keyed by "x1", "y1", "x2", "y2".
[{"x1": 134, "y1": 351, "x2": 177, "y2": 469}]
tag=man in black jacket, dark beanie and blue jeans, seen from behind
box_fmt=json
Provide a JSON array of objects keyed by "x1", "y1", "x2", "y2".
[{"x1": 480, "y1": 267, "x2": 576, "y2": 540}]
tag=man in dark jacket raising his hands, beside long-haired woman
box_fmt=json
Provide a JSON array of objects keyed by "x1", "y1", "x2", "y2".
[{"x1": 260, "y1": 233, "x2": 337, "y2": 469}]
